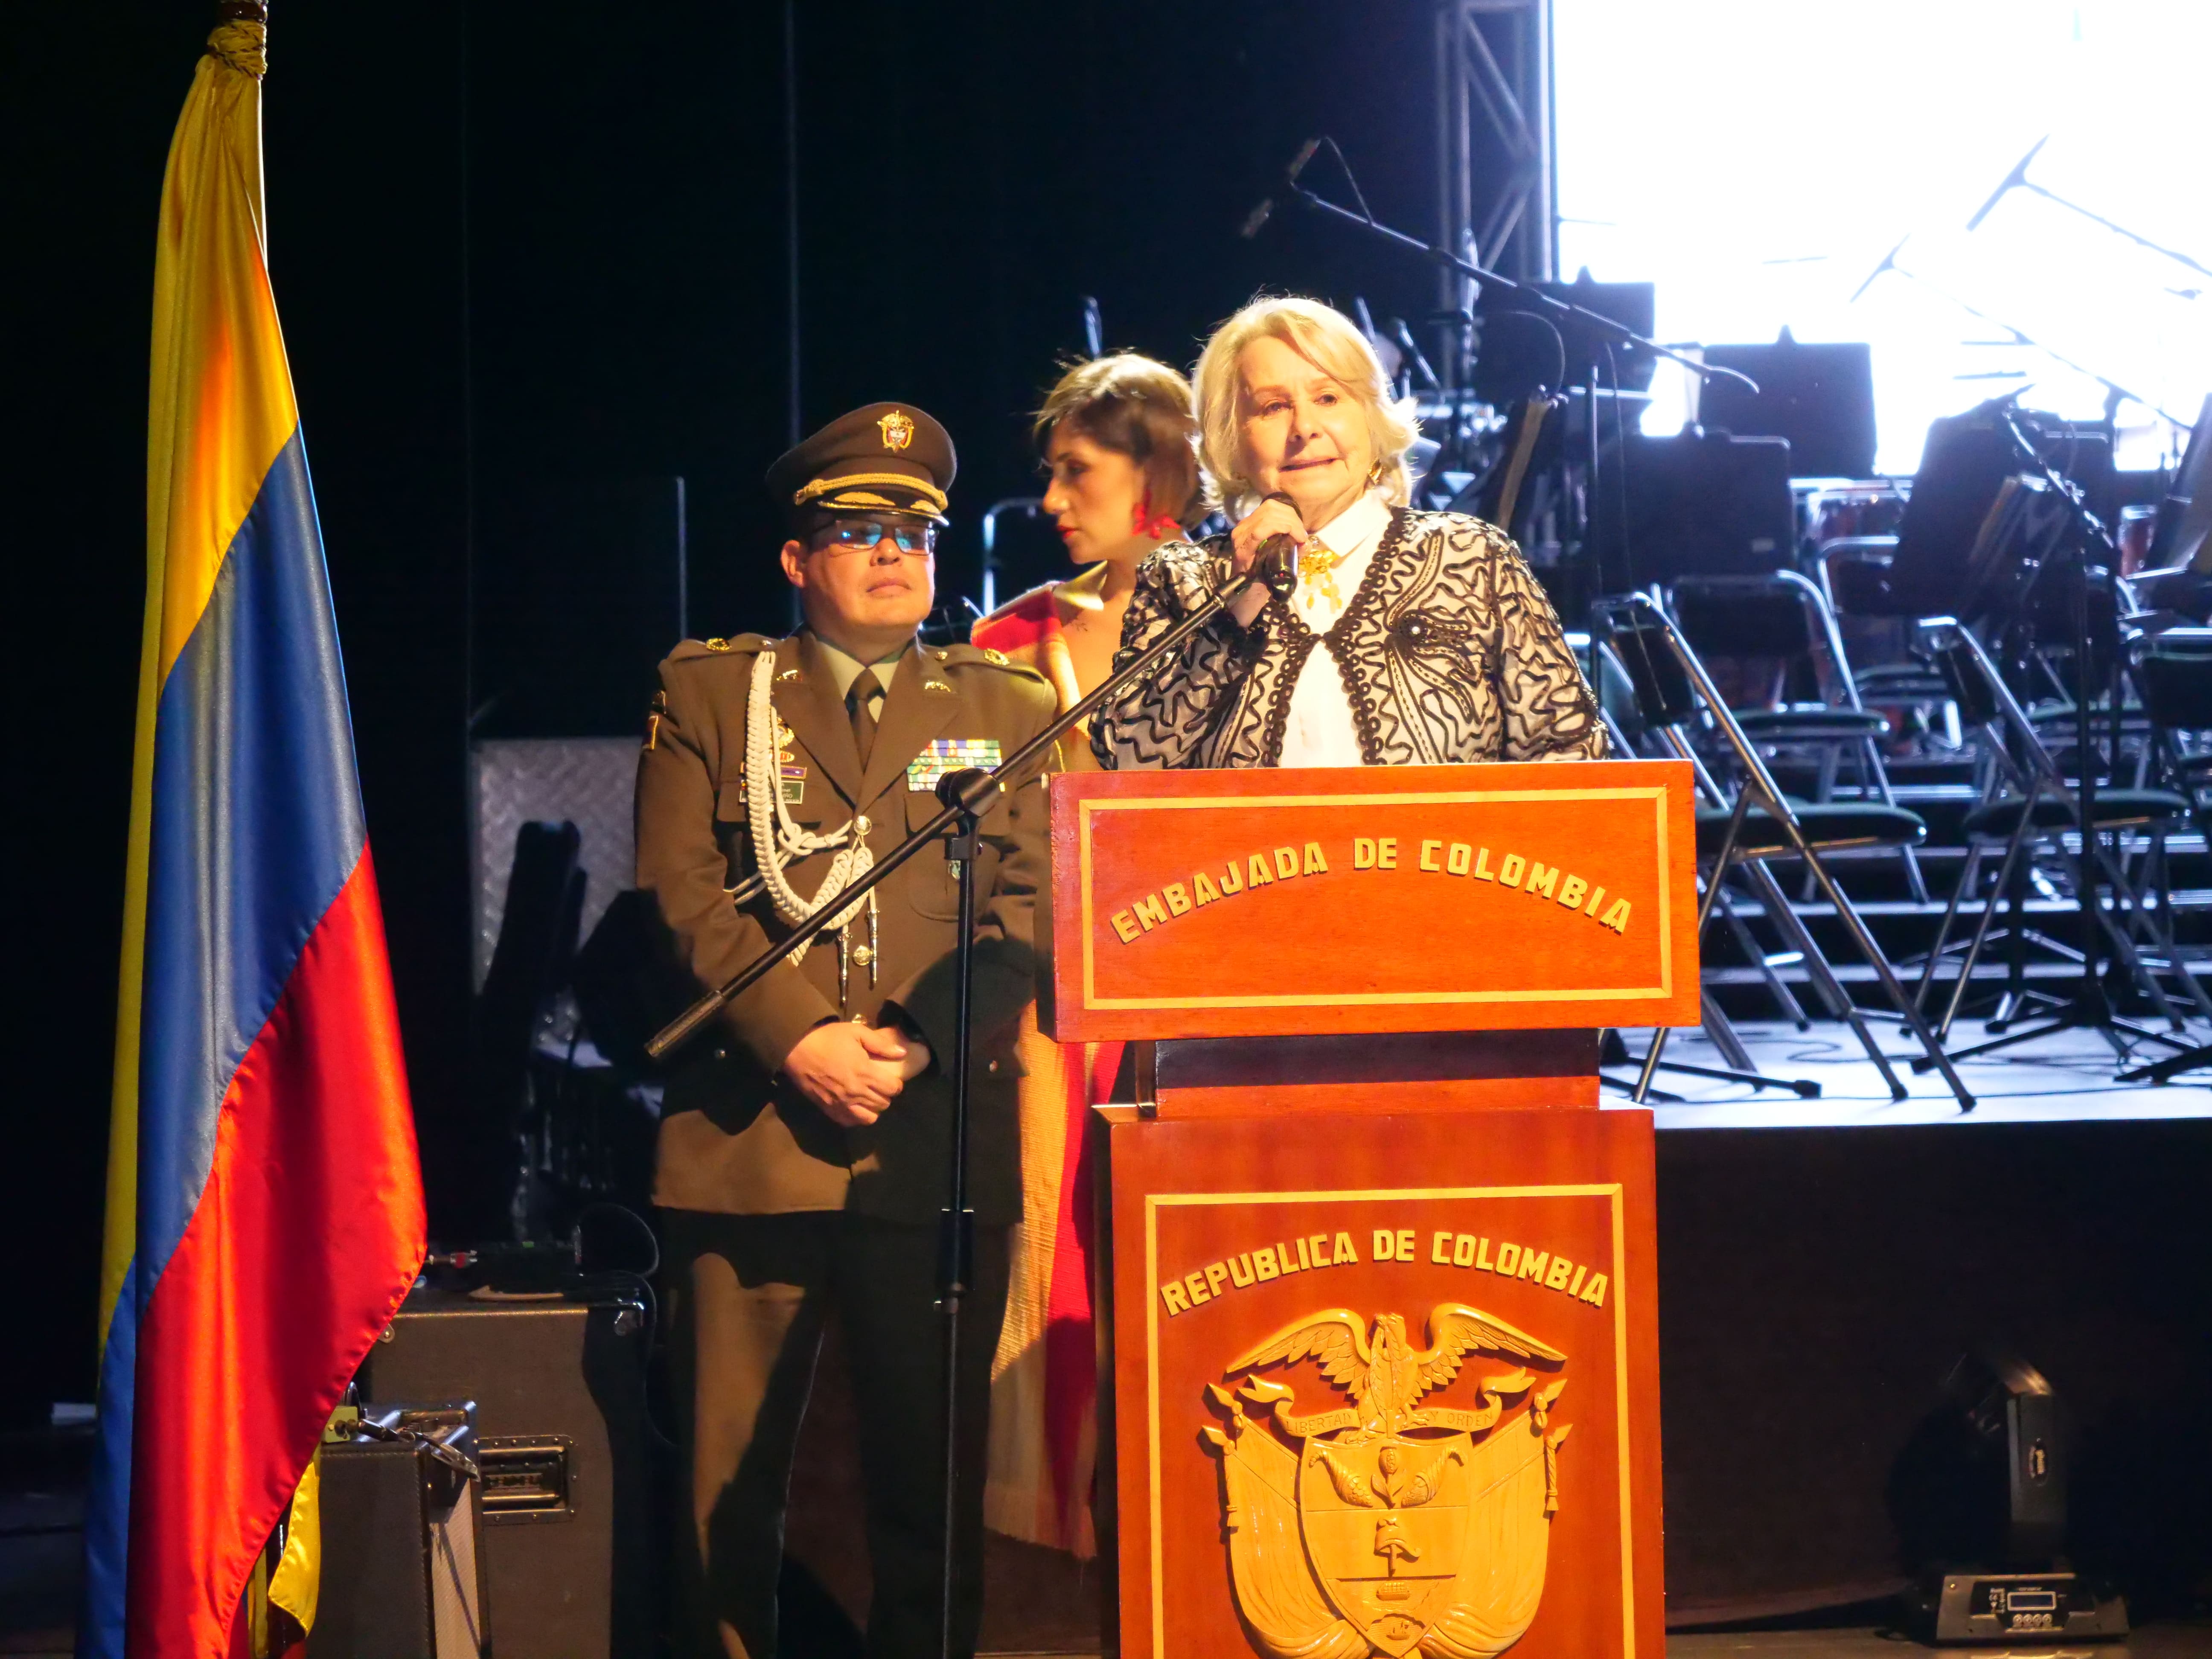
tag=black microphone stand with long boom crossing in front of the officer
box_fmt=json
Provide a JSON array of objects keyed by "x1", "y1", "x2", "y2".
[{"x1": 646, "y1": 553, "x2": 1298, "y2": 1659}]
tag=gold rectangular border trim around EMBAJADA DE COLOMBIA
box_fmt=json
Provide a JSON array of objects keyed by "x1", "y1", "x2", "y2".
[{"x1": 1077, "y1": 785, "x2": 1674, "y2": 1011}]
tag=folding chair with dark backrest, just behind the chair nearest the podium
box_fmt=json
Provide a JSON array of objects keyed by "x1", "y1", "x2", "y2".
[{"x1": 1668, "y1": 570, "x2": 1929, "y2": 905}]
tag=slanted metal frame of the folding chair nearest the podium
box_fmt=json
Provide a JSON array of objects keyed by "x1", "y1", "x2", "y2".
[{"x1": 1592, "y1": 593, "x2": 1973, "y2": 1113}]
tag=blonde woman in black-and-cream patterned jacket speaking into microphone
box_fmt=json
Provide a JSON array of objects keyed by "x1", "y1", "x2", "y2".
[{"x1": 1091, "y1": 299, "x2": 1606, "y2": 768}]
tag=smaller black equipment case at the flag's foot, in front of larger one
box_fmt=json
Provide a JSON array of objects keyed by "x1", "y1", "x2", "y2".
[{"x1": 305, "y1": 1403, "x2": 489, "y2": 1659}]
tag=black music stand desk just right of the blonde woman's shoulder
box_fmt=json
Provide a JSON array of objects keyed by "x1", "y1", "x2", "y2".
[{"x1": 1588, "y1": 427, "x2": 1796, "y2": 593}]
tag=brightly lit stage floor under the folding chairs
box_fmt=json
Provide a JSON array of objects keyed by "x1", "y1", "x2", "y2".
[{"x1": 1604, "y1": 1020, "x2": 2212, "y2": 1130}]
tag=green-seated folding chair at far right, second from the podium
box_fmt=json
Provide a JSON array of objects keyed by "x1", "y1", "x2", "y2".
[{"x1": 1915, "y1": 617, "x2": 2212, "y2": 1066}]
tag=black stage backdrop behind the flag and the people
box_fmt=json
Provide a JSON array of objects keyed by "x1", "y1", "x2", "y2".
[{"x1": 17, "y1": 0, "x2": 1433, "y2": 1420}]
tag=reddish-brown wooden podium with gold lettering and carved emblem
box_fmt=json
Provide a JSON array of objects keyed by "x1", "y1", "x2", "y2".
[{"x1": 1044, "y1": 761, "x2": 1699, "y2": 1659}]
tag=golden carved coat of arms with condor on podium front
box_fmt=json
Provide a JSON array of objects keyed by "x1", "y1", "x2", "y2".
[{"x1": 1203, "y1": 1303, "x2": 1568, "y2": 1659}]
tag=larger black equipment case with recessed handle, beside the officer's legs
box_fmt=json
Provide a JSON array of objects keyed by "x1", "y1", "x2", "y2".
[{"x1": 363, "y1": 1289, "x2": 664, "y2": 1659}]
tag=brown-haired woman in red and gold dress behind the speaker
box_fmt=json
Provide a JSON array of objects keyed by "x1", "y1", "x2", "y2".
[{"x1": 973, "y1": 352, "x2": 1205, "y2": 1560}]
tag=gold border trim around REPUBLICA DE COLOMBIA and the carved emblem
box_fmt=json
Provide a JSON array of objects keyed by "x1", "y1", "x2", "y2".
[{"x1": 1141, "y1": 1185, "x2": 1663, "y2": 1659}]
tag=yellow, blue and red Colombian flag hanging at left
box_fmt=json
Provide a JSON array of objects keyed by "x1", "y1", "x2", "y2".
[{"x1": 80, "y1": 0, "x2": 422, "y2": 1659}]
